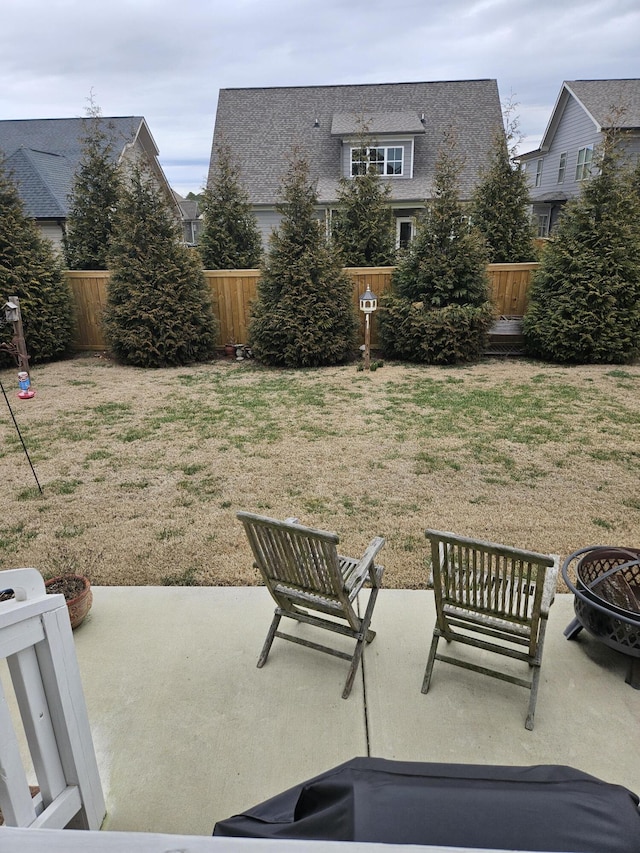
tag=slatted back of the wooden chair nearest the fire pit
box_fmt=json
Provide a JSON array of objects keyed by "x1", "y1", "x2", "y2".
[{"x1": 426, "y1": 530, "x2": 554, "y2": 644}]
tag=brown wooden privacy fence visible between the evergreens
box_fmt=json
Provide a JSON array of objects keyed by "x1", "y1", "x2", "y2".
[{"x1": 66, "y1": 263, "x2": 538, "y2": 350}]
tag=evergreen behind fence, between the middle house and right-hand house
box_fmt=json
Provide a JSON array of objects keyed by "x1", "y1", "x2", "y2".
[{"x1": 471, "y1": 113, "x2": 535, "y2": 264}]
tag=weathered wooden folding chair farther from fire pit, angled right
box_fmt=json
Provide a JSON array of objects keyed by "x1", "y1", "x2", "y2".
[{"x1": 238, "y1": 512, "x2": 384, "y2": 699}]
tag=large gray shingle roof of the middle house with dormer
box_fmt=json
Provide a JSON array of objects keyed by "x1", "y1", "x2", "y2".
[{"x1": 211, "y1": 80, "x2": 502, "y2": 205}]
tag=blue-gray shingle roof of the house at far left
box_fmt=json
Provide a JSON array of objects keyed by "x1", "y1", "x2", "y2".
[{"x1": 0, "y1": 116, "x2": 144, "y2": 219}]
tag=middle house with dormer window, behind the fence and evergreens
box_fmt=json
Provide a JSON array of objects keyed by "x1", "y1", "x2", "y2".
[{"x1": 209, "y1": 80, "x2": 502, "y2": 250}]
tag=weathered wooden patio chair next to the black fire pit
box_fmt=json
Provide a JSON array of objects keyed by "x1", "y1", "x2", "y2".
[{"x1": 422, "y1": 530, "x2": 558, "y2": 730}]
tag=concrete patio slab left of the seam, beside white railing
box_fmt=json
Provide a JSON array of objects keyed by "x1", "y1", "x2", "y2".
[{"x1": 75, "y1": 587, "x2": 367, "y2": 835}]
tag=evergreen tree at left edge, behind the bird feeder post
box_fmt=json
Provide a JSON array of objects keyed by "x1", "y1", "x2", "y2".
[{"x1": 0, "y1": 159, "x2": 73, "y2": 364}]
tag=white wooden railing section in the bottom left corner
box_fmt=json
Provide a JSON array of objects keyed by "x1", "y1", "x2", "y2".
[{"x1": 0, "y1": 569, "x2": 105, "y2": 829}]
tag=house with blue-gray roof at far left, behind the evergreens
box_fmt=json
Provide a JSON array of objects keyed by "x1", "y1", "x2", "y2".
[{"x1": 0, "y1": 116, "x2": 182, "y2": 247}]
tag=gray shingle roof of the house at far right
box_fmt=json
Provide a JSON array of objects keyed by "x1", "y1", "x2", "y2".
[{"x1": 565, "y1": 79, "x2": 640, "y2": 129}]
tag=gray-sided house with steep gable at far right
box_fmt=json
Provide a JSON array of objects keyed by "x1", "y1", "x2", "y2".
[{"x1": 520, "y1": 80, "x2": 640, "y2": 237}]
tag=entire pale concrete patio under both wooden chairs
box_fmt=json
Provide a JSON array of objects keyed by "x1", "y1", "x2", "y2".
[{"x1": 0, "y1": 587, "x2": 640, "y2": 835}]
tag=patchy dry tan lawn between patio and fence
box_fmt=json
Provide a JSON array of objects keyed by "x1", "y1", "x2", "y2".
[{"x1": 0, "y1": 356, "x2": 640, "y2": 587}]
